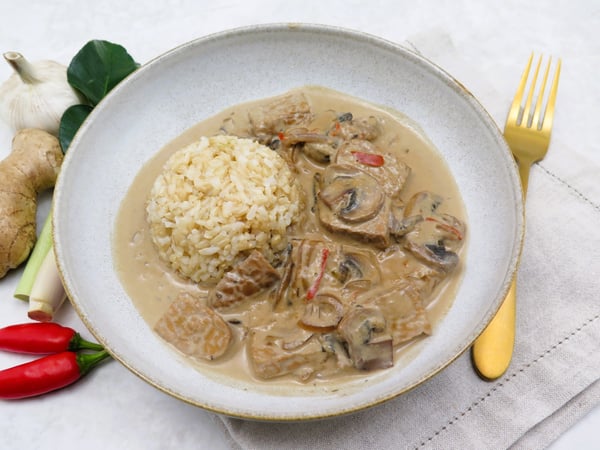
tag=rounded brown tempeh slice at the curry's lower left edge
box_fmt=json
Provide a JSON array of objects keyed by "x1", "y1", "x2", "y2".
[{"x1": 154, "y1": 294, "x2": 232, "y2": 360}]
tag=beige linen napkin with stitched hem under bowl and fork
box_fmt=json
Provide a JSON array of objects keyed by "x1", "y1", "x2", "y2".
[{"x1": 216, "y1": 29, "x2": 600, "y2": 450}]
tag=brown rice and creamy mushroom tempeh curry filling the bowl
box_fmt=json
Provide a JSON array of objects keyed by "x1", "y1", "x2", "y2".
[{"x1": 114, "y1": 87, "x2": 466, "y2": 382}]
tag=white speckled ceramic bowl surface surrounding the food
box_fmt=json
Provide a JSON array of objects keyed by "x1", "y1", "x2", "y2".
[{"x1": 53, "y1": 24, "x2": 523, "y2": 421}]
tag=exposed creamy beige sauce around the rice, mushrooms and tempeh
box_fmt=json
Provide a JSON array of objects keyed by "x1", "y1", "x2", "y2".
[{"x1": 113, "y1": 87, "x2": 466, "y2": 385}]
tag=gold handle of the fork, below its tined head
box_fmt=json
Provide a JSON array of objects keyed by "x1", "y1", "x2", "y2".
[{"x1": 471, "y1": 159, "x2": 533, "y2": 380}]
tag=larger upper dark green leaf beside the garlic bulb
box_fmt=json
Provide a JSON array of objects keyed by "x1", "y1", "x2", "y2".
[{"x1": 67, "y1": 40, "x2": 139, "y2": 106}]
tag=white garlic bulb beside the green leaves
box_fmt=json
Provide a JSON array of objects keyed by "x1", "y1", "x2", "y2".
[{"x1": 0, "y1": 52, "x2": 82, "y2": 136}]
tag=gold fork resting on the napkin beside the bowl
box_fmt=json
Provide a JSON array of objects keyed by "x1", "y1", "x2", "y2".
[{"x1": 472, "y1": 53, "x2": 561, "y2": 380}]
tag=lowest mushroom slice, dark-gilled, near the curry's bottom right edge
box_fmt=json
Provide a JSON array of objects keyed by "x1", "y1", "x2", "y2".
[{"x1": 338, "y1": 307, "x2": 394, "y2": 370}]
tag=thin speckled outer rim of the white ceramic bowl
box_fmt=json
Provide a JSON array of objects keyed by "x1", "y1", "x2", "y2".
[{"x1": 53, "y1": 24, "x2": 524, "y2": 421}]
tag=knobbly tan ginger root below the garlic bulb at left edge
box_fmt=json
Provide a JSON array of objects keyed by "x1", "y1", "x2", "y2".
[{"x1": 0, "y1": 128, "x2": 63, "y2": 278}]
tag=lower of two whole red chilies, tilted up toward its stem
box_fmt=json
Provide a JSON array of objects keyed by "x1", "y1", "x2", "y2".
[{"x1": 0, "y1": 350, "x2": 109, "y2": 399}]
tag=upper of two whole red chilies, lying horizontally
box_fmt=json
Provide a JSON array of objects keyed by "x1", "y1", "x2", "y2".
[{"x1": 0, "y1": 322, "x2": 103, "y2": 354}]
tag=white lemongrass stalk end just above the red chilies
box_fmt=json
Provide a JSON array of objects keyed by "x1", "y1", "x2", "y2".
[{"x1": 27, "y1": 248, "x2": 67, "y2": 322}]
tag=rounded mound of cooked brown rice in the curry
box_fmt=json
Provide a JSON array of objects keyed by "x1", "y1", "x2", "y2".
[{"x1": 146, "y1": 136, "x2": 302, "y2": 282}]
